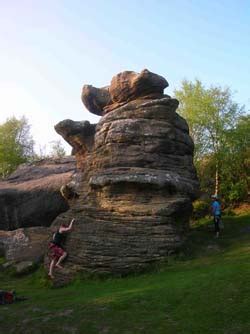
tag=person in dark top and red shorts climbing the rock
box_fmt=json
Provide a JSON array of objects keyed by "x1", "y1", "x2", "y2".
[{"x1": 48, "y1": 218, "x2": 75, "y2": 278}]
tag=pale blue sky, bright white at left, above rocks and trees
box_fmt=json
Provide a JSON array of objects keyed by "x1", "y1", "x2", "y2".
[{"x1": 0, "y1": 0, "x2": 250, "y2": 153}]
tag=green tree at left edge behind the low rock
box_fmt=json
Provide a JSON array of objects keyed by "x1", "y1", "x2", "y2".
[{"x1": 0, "y1": 116, "x2": 34, "y2": 177}]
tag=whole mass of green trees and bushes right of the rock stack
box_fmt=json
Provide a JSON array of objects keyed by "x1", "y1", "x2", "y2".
[{"x1": 175, "y1": 80, "x2": 247, "y2": 205}]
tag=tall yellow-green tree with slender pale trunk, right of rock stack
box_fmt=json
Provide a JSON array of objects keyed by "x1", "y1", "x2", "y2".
[{"x1": 175, "y1": 80, "x2": 244, "y2": 194}]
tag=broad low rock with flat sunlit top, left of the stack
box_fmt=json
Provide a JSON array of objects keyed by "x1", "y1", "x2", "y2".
[{"x1": 0, "y1": 157, "x2": 76, "y2": 230}]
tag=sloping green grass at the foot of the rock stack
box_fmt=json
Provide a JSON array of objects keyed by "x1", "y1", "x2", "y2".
[{"x1": 0, "y1": 214, "x2": 250, "y2": 334}]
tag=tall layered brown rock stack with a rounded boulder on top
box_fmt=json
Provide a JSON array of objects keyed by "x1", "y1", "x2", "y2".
[{"x1": 50, "y1": 71, "x2": 199, "y2": 281}]
